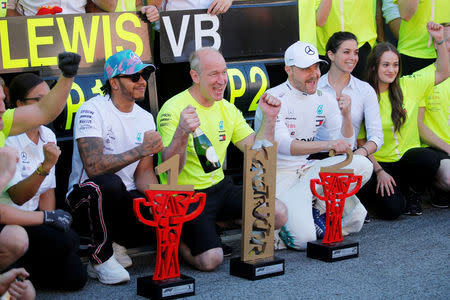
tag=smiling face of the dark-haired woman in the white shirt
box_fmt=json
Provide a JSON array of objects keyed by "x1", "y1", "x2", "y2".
[{"x1": 327, "y1": 39, "x2": 359, "y2": 73}]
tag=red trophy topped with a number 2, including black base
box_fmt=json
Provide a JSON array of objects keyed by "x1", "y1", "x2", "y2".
[{"x1": 306, "y1": 149, "x2": 362, "y2": 262}]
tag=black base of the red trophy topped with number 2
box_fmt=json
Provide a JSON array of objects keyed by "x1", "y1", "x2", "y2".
[{"x1": 306, "y1": 240, "x2": 359, "y2": 262}]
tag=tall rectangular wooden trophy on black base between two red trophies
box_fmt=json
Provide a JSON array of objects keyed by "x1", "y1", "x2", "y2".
[{"x1": 230, "y1": 141, "x2": 284, "y2": 280}]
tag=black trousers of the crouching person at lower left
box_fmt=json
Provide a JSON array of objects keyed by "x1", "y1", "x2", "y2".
[{"x1": 16, "y1": 225, "x2": 87, "y2": 290}]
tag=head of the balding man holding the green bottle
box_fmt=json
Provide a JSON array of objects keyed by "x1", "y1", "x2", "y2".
[{"x1": 191, "y1": 49, "x2": 228, "y2": 106}]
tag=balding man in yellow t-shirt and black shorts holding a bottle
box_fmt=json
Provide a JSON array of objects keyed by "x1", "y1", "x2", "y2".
[{"x1": 157, "y1": 48, "x2": 287, "y2": 271}]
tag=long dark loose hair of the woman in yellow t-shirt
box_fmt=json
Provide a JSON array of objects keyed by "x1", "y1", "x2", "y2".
[{"x1": 366, "y1": 42, "x2": 406, "y2": 132}]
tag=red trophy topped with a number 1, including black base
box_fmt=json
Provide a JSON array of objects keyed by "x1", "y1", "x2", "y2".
[{"x1": 133, "y1": 155, "x2": 206, "y2": 299}]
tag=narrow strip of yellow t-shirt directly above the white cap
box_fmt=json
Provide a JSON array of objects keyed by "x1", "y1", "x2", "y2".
[{"x1": 298, "y1": 0, "x2": 321, "y2": 46}]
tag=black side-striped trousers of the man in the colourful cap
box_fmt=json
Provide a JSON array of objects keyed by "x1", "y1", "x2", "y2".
[{"x1": 66, "y1": 174, "x2": 155, "y2": 264}]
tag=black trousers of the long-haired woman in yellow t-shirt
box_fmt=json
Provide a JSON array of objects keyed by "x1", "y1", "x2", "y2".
[{"x1": 358, "y1": 148, "x2": 441, "y2": 220}]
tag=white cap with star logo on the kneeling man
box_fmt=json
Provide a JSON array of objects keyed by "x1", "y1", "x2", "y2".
[{"x1": 284, "y1": 41, "x2": 328, "y2": 69}]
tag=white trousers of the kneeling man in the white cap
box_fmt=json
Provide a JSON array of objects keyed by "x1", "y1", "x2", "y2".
[{"x1": 276, "y1": 155, "x2": 373, "y2": 250}]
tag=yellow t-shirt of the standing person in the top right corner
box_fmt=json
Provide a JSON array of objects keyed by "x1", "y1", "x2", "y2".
[{"x1": 394, "y1": 0, "x2": 450, "y2": 58}]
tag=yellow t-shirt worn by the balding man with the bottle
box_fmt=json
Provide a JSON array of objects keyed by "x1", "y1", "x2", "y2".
[{"x1": 156, "y1": 89, "x2": 253, "y2": 189}]
